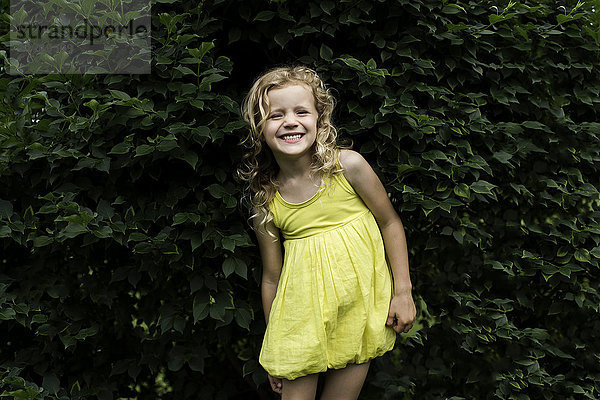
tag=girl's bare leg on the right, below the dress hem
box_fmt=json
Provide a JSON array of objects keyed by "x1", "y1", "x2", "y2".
[{"x1": 321, "y1": 361, "x2": 371, "y2": 400}]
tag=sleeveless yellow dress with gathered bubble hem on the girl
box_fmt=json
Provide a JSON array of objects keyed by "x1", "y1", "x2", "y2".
[{"x1": 259, "y1": 162, "x2": 396, "y2": 380}]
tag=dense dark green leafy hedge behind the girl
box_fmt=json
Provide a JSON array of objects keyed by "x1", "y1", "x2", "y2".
[{"x1": 0, "y1": 0, "x2": 600, "y2": 400}]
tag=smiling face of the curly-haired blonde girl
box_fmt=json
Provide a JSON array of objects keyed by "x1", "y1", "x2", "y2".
[{"x1": 263, "y1": 84, "x2": 319, "y2": 158}]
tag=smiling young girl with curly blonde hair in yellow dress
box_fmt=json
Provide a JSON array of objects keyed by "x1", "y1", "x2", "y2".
[{"x1": 239, "y1": 66, "x2": 416, "y2": 400}]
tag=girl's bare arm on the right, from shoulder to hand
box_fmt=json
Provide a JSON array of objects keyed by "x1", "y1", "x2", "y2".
[{"x1": 340, "y1": 150, "x2": 416, "y2": 332}]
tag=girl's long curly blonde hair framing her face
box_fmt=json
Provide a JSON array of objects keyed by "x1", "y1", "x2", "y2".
[{"x1": 237, "y1": 66, "x2": 352, "y2": 237}]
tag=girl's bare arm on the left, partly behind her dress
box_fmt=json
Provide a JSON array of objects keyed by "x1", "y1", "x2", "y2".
[{"x1": 254, "y1": 209, "x2": 283, "y2": 324}]
